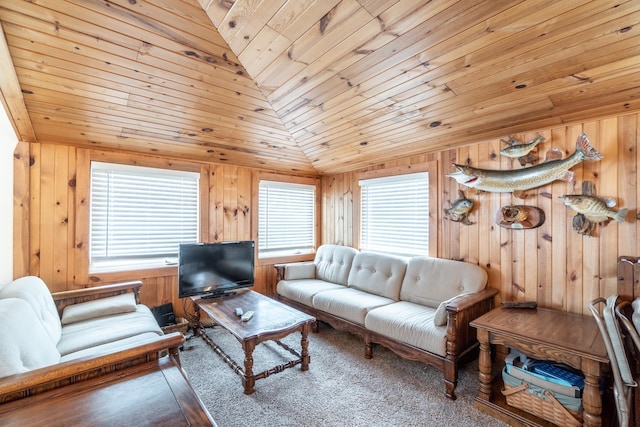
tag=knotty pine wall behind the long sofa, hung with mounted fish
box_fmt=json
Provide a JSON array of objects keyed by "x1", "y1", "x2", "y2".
[{"x1": 322, "y1": 115, "x2": 640, "y2": 314}]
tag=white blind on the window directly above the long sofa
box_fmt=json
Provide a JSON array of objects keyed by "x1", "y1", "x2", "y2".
[{"x1": 360, "y1": 172, "x2": 429, "y2": 256}]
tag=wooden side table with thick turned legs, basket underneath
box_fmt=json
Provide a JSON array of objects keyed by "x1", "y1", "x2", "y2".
[{"x1": 471, "y1": 307, "x2": 609, "y2": 427}]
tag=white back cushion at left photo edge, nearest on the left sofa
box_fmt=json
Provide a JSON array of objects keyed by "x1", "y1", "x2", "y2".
[{"x1": 0, "y1": 298, "x2": 60, "y2": 377}]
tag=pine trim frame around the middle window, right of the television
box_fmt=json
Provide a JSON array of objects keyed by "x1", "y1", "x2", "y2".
[{"x1": 251, "y1": 172, "x2": 321, "y2": 265}]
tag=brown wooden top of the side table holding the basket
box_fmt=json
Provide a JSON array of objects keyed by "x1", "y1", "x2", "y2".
[{"x1": 470, "y1": 307, "x2": 609, "y2": 362}]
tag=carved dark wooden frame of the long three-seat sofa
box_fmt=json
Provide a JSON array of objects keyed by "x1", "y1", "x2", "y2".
[{"x1": 275, "y1": 264, "x2": 498, "y2": 400}]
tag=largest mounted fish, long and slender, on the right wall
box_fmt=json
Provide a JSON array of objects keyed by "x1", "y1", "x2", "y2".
[{"x1": 447, "y1": 133, "x2": 602, "y2": 193}]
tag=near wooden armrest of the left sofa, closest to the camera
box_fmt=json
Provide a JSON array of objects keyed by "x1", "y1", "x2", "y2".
[{"x1": 0, "y1": 332, "x2": 184, "y2": 404}]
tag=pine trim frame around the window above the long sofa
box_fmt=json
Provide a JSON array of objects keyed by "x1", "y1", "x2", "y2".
[{"x1": 354, "y1": 160, "x2": 439, "y2": 257}]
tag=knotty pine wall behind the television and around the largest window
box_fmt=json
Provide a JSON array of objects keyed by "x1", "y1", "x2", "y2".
[{"x1": 14, "y1": 143, "x2": 308, "y2": 313}]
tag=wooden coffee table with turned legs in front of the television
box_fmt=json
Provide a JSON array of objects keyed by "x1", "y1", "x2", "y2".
[{"x1": 191, "y1": 290, "x2": 316, "y2": 394}]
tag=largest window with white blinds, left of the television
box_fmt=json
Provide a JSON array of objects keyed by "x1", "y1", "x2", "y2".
[{"x1": 89, "y1": 162, "x2": 200, "y2": 272}]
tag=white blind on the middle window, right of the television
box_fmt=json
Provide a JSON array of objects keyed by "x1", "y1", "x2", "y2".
[{"x1": 258, "y1": 180, "x2": 316, "y2": 257}]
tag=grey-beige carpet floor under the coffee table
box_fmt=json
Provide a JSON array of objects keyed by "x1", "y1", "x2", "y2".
[{"x1": 180, "y1": 325, "x2": 506, "y2": 427}]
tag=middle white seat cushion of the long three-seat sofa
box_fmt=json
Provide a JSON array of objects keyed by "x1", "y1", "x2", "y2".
[{"x1": 313, "y1": 287, "x2": 394, "y2": 325}]
